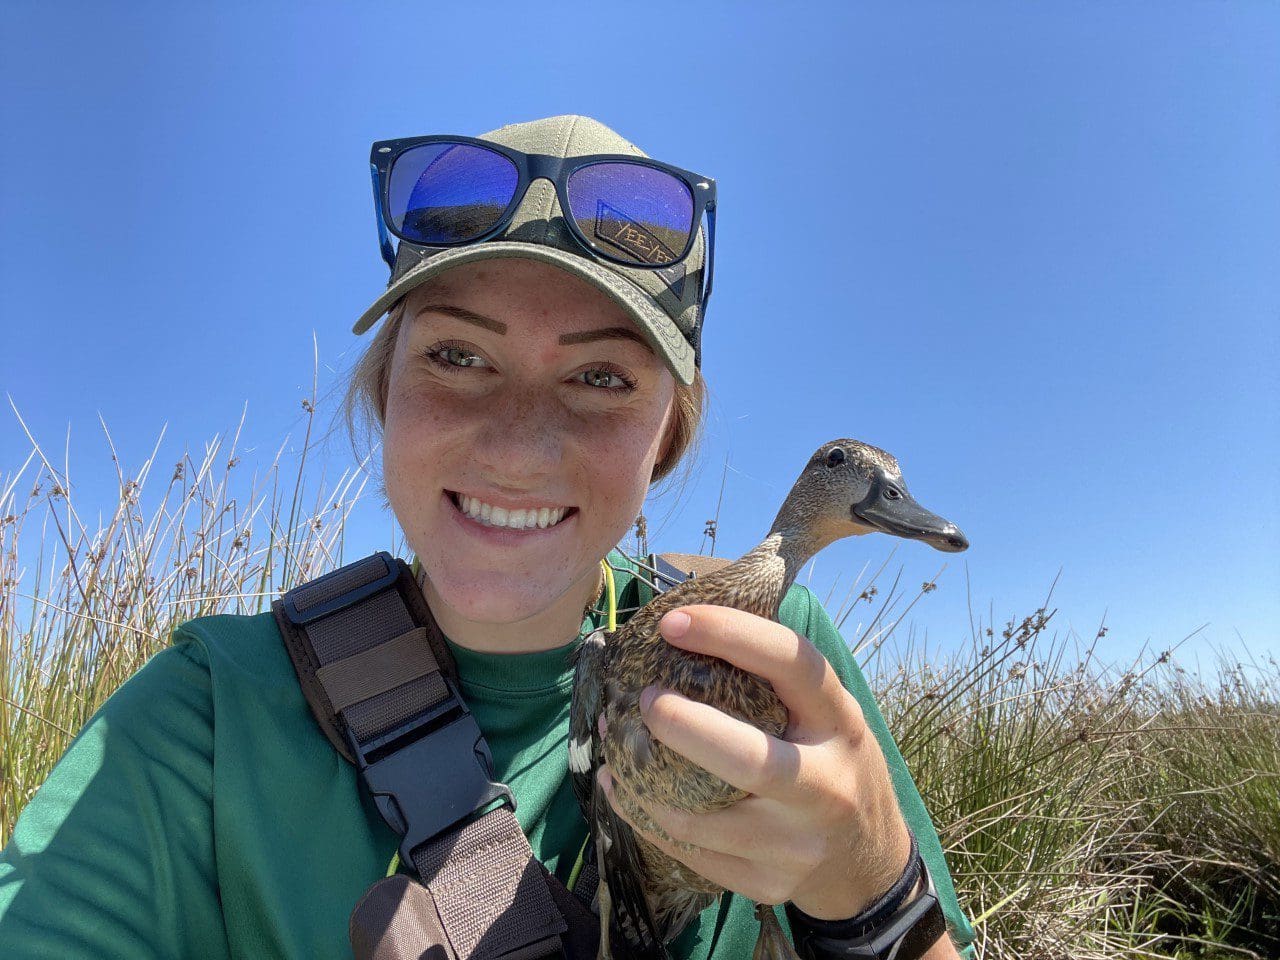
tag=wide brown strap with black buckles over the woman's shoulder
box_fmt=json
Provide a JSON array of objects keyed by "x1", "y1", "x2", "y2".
[{"x1": 271, "y1": 552, "x2": 568, "y2": 960}]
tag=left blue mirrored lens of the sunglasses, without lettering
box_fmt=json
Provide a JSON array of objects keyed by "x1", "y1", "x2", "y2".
[{"x1": 388, "y1": 143, "x2": 520, "y2": 246}]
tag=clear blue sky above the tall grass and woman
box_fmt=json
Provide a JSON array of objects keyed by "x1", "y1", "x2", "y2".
[{"x1": 0, "y1": 3, "x2": 1280, "y2": 660}]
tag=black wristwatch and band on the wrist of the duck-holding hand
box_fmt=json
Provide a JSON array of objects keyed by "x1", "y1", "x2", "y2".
[{"x1": 786, "y1": 833, "x2": 947, "y2": 960}]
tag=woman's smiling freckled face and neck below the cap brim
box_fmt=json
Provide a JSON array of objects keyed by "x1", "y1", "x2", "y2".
[{"x1": 383, "y1": 260, "x2": 675, "y2": 643}]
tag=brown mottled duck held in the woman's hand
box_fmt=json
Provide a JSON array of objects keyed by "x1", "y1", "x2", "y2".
[{"x1": 568, "y1": 439, "x2": 969, "y2": 960}]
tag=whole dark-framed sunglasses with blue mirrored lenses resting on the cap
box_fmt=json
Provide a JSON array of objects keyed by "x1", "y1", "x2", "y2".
[{"x1": 369, "y1": 136, "x2": 716, "y2": 304}]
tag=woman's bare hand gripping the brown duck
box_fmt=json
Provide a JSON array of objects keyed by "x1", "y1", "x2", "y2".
[{"x1": 599, "y1": 604, "x2": 910, "y2": 919}]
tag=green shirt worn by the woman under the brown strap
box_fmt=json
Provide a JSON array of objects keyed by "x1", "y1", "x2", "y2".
[{"x1": 0, "y1": 552, "x2": 973, "y2": 960}]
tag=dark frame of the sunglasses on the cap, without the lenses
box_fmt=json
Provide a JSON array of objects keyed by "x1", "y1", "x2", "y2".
[{"x1": 369, "y1": 134, "x2": 716, "y2": 312}]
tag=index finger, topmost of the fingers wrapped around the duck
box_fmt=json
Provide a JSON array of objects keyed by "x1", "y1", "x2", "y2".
[{"x1": 658, "y1": 604, "x2": 863, "y2": 739}]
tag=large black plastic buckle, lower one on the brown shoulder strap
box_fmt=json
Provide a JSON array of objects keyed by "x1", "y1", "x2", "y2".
[{"x1": 344, "y1": 677, "x2": 516, "y2": 867}]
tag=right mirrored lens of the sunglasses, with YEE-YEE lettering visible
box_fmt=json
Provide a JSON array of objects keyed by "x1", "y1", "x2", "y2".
[{"x1": 568, "y1": 161, "x2": 696, "y2": 266}]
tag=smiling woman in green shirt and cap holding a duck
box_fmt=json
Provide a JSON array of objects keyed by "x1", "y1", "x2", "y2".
[{"x1": 0, "y1": 118, "x2": 972, "y2": 960}]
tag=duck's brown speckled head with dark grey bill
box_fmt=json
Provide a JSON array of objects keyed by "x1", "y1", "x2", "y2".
[{"x1": 773, "y1": 439, "x2": 969, "y2": 553}]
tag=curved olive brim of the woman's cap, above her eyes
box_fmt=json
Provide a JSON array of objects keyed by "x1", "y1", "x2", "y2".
[{"x1": 351, "y1": 241, "x2": 694, "y2": 385}]
